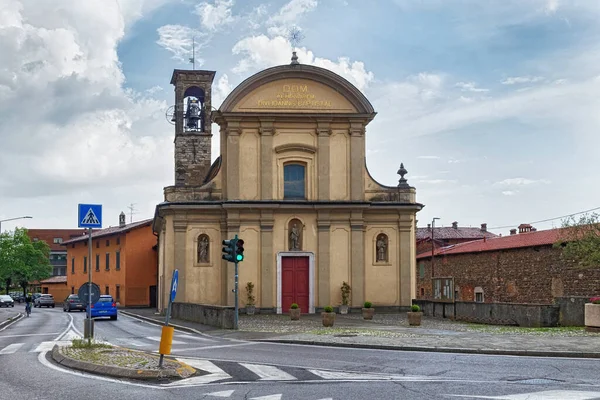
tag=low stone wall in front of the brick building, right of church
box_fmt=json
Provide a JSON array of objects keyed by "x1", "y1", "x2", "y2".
[{"x1": 413, "y1": 300, "x2": 560, "y2": 327}]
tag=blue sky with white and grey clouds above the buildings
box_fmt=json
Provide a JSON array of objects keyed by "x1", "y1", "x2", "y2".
[{"x1": 0, "y1": 0, "x2": 600, "y2": 234}]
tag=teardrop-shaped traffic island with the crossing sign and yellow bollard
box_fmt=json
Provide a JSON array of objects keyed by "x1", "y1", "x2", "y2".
[{"x1": 51, "y1": 343, "x2": 199, "y2": 383}]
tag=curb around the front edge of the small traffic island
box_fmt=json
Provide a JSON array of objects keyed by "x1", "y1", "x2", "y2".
[{"x1": 52, "y1": 345, "x2": 197, "y2": 380}]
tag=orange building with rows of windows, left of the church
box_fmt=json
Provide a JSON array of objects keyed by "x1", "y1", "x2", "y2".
[{"x1": 63, "y1": 213, "x2": 158, "y2": 307}]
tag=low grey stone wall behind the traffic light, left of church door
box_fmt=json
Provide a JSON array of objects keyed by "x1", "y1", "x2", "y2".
[{"x1": 171, "y1": 303, "x2": 235, "y2": 329}]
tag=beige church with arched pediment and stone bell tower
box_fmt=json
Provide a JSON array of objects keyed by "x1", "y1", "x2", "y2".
[{"x1": 154, "y1": 54, "x2": 423, "y2": 313}]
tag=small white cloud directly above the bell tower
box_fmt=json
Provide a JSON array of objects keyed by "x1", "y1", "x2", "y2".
[{"x1": 156, "y1": 25, "x2": 210, "y2": 66}]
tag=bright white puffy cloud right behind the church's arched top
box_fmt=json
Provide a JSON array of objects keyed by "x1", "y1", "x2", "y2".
[{"x1": 232, "y1": 35, "x2": 375, "y2": 90}]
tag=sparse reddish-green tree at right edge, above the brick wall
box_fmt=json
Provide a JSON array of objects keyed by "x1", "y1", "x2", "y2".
[{"x1": 554, "y1": 213, "x2": 600, "y2": 268}]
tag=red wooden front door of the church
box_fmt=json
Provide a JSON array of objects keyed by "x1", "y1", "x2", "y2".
[{"x1": 281, "y1": 257, "x2": 309, "y2": 313}]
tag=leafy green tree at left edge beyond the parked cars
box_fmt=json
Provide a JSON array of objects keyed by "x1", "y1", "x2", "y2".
[{"x1": 0, "y1": 228, "x2": 52, "y2": 294}]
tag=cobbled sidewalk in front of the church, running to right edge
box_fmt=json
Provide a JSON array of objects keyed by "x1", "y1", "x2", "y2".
[{"x1": 120, "y1": 309, "x2": 600, "y2": 358}]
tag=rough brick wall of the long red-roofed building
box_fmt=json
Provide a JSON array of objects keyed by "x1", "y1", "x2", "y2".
[{"x1": 417, "y1": 246, "x2": 600, "y2": 304}]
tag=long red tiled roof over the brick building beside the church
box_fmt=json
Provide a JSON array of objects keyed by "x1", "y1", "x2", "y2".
[{"x1": 417, "y1": 228, "x2": 562, "y2": 259}]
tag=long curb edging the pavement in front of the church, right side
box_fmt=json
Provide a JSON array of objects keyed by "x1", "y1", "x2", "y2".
[{"x1": 248, "y1": 339, "x2": 600, "y2": 358}]
